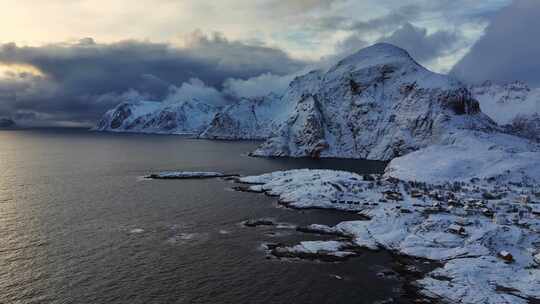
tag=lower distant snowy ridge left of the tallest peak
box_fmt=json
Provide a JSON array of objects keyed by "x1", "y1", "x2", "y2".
[{"x1": 94, "y1": 94, "x2": 287, "y2": 140}]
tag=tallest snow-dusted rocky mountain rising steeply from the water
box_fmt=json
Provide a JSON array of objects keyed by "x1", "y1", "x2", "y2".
[{"x1": 253, "y1": 44, "x2": 497, "y2": 160}]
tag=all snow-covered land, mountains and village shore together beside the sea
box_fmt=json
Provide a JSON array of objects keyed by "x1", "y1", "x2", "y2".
[{"x1": 97, "y1": 44, "x2": 540, "y2": 304}]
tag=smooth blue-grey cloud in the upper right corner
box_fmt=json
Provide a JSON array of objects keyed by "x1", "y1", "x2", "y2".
[{"x1": 452, "y1": 0, "x2": 540, "y2": 86}]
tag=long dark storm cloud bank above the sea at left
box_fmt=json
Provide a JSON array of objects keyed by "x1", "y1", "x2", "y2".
[{"x1": 0, "y1": 32, "x2": 304, "y2": 127}]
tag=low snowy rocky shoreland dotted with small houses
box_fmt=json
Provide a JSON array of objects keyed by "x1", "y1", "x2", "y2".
[{"x1": 240, "y1": 169, "x2": 540, "y2": 304}]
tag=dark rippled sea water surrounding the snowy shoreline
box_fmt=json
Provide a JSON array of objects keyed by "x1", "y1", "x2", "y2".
[{"x1": 0, "y1": 129, "x2": 422, "y2": 304}]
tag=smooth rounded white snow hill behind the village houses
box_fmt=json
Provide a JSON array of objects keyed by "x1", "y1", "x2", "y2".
[{"x1": 386, "y1": 131, "x2": 540, "y2": 183}]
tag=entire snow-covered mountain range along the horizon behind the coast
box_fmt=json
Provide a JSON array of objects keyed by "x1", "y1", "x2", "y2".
[{"x1": 96, "y1": 44, "x2": 540, "y2": 167}]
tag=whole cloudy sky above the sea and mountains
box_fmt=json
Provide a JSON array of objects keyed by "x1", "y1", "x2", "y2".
[{"x1": 0, "y1": 0, "x2": 540, "y2": 126}]
